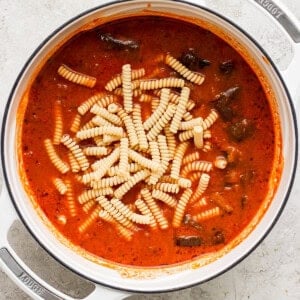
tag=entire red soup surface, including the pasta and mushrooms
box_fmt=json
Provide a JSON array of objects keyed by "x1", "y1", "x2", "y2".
[{"x1": 21, "y1": 16, "x2": 274, "y2": 266}]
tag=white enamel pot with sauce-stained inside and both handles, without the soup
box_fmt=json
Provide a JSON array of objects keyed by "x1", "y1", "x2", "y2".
[{"x1": 0, "y1": 0, "x2": 300, "y2": 299}]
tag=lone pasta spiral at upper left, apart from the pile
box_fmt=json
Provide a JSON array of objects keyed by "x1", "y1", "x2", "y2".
[{"x1": 57, "y1": 64, "x2": 97, "y2": 88}]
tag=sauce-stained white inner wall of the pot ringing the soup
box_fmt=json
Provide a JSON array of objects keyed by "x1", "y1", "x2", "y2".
[{"x1": 2, "y1": 1, "x2": 296, "y2": 292}]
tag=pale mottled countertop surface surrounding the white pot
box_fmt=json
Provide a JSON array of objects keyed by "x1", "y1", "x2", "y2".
[{"x1": 0, "y1": 0, "x2": 300, "y2": 300}]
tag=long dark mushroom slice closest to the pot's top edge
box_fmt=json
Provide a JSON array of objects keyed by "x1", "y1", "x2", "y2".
[{"x1": 98, "y1": 32, "x2": 140, "y2": 50}]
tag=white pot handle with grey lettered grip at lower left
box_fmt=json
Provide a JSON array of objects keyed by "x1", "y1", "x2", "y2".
[{"x1": 0, "y1": 187, "x2": 129, "y2": 300}]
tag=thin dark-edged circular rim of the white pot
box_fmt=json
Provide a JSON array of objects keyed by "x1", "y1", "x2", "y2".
[{"x1": 1, "y1": 0, "x2": 298, "y2": 294}]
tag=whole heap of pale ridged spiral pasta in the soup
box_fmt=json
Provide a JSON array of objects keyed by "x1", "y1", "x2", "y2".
[{"x1": 44, "y1": 54, "x2": 227, "y2": 240}]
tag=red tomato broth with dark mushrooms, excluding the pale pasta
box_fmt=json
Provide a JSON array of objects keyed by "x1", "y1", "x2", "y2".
[{"x1": 21, "y1": 16, "x2": 275, "y2": 266}]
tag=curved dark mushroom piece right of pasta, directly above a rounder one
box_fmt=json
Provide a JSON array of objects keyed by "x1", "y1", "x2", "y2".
[{"x1": 214, "y1": 86, "x2": 240, "y2": 121}]
